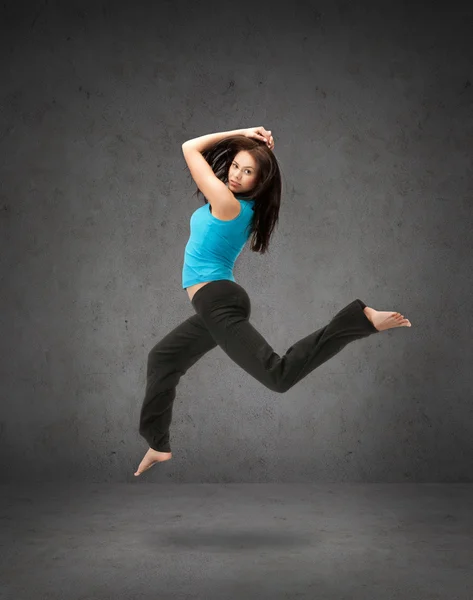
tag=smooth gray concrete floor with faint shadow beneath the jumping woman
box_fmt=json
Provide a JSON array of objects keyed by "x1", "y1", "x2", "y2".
[{"x1": 0, "y1": 476, "x2": 473, "y2": 600}]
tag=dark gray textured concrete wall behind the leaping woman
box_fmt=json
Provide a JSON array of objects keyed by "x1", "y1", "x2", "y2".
[{"x1": 0, "y1": 0, "x2": 473, "y2": 482}]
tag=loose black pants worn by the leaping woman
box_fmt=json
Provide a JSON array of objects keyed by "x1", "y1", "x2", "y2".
[{"x1": 139, "y1": 279, "x2": 378, "y2": 452}]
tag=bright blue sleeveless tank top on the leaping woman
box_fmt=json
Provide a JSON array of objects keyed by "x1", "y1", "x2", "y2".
[{"x1": 182, "y1": 198, "x2": 255, "y2": 289}]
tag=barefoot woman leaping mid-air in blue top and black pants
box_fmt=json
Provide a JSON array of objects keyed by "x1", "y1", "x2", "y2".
[{"x1": 135, "y1": 127, "x2": 411, "y2": 476}]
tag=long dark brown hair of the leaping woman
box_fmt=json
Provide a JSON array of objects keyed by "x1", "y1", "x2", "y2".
[{"x1": 188, "y1": 135, "x2": 281, "y2": 254}]
